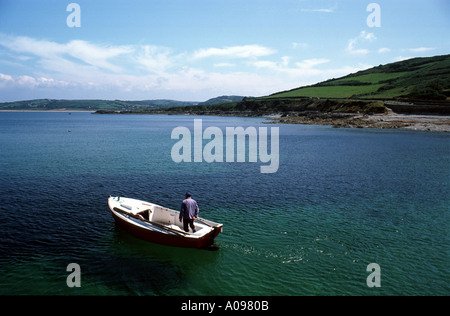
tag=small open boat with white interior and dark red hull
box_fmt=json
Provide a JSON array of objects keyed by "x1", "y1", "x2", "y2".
[{"x1": 108, "y1": 196, "x2": 223, "y2": 249}]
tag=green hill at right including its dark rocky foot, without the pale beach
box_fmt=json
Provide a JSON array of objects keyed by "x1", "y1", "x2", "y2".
[{"x1": 149, "y1": 55, "x2": 450, "y2": 116}]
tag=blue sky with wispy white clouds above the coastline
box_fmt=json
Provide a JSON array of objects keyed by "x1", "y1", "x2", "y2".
[{"x1": 0, "y1": 0, "x2": 450, "y2": 102}]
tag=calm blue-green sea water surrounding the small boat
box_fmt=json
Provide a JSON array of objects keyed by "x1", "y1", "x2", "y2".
[{"x1": 0, "y1": 113, "x2": 450, "y2": 295}]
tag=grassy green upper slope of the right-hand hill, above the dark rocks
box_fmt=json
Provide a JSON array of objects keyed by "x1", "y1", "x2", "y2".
[{"x1": 268, "y1": 55, "x2": 450, "y2": 101}]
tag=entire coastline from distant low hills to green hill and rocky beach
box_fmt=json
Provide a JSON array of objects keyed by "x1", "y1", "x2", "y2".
[{"x1": 0, "y1": 55, "x2": 450, "y2": 131}]
